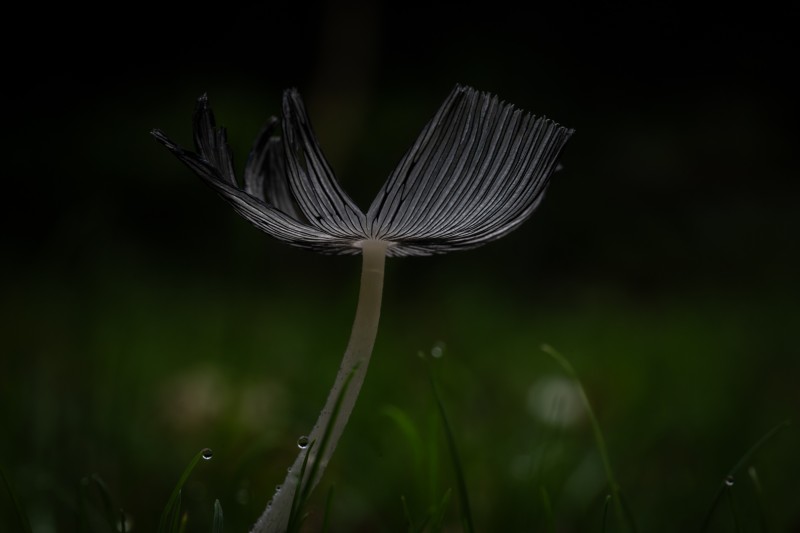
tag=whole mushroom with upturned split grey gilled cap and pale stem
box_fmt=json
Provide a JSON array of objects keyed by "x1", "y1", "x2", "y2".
[{"x1": 152, "y1": 85, "x2": 573, "y2": 533}]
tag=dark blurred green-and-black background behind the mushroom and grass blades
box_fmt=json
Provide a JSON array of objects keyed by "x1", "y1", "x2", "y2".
[{"x1": 0, "y1": 0, "x2": 800, "y2": 533}]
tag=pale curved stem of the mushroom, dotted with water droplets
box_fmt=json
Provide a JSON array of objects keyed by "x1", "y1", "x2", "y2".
[{"x1": 252, "y1": 240, "x2": 388, "y2": 533}]
